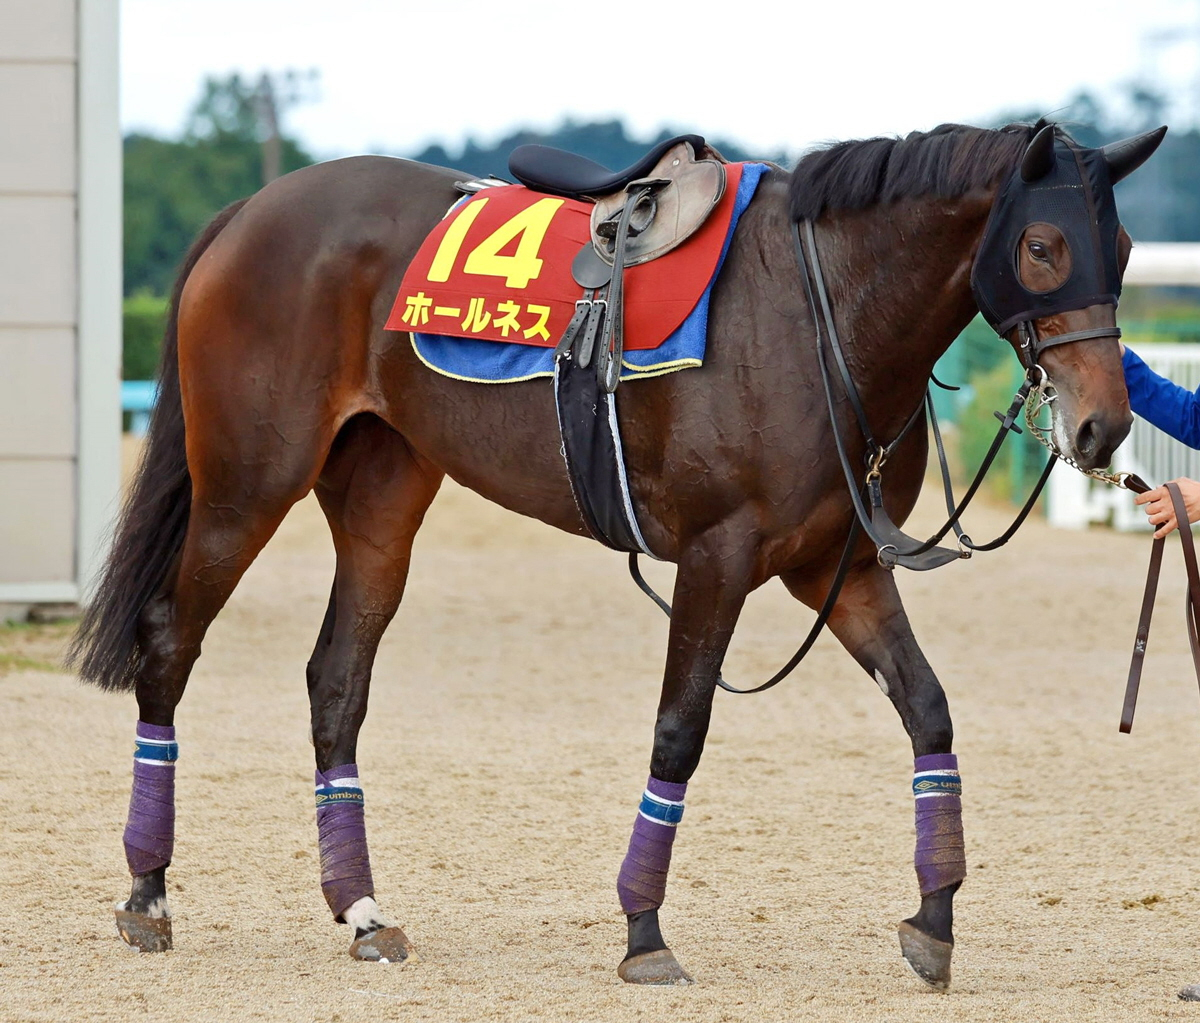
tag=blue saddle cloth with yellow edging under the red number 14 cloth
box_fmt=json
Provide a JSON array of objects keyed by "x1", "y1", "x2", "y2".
[{"x1": 412, "y1": 163, "x2": 769, "y2": 383}]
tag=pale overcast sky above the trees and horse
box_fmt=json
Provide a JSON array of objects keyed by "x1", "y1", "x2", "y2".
[{"x1": 121, "y1": 0, "x2": 1200, "y2": 156}]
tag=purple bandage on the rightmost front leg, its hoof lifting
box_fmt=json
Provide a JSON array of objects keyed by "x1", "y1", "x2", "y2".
[{"x1": 912, "y1": 753, "x2": 967, "y2": 896}]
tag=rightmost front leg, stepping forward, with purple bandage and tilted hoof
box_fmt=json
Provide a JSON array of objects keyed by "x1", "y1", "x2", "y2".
[{"x1": 784, "y1": 561, "x2": 966, "y2": 989}]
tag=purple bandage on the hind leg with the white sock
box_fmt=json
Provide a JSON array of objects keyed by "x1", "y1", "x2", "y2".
[{"x1": 317, "y1": 764, "x2": 374, "y2": 921}]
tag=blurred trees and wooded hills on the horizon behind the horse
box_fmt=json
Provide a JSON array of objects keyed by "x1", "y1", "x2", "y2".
[{"x1": 125, "y1": 72, "x2": 1200, "y2": 379}]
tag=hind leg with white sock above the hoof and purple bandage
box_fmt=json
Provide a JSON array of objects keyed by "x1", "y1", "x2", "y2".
[{"x1": 307, "y1": 415, "x2": 442, "y2": 962}]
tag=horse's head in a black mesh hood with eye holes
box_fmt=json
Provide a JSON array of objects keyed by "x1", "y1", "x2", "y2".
[{"x1": 971, "y1": 125, "x2": 1166, "y2": 468}]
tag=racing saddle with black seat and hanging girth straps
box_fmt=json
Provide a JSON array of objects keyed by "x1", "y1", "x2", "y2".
[{"x1": 509, "y1": 134, "x2": 725, "y2": 394}]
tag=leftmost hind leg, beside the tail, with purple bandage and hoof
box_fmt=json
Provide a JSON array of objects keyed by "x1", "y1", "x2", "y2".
[{"x1": 116, "y1": 454, "x2": 317, "y2": 952}]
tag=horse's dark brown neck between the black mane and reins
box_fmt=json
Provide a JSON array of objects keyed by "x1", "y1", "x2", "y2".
[{"x1": 818, "y1": 195, "x2": 991, "y2": 435}]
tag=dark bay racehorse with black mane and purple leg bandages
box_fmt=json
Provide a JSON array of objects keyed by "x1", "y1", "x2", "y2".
[{"x1": 70, "y1": 115, "x2": 1162, "y2": 987}]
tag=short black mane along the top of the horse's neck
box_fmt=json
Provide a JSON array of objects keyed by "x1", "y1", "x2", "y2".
[{"x1": 790, "y1": 119, "x2": 1063, "y2": 220}]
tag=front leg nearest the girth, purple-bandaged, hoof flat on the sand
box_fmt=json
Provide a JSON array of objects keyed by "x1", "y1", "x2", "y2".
[{"x1": 617, "y1": 531, "x2": 754, "y2": 985}]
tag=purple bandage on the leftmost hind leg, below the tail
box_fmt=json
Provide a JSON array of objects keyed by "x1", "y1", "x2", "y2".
[{"x1": 125, "y1": 722, "x2": 179, "y2": 877}]
